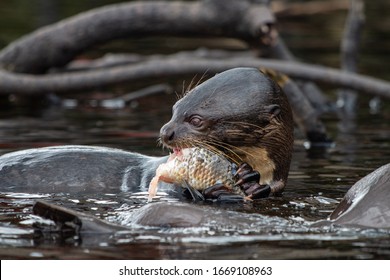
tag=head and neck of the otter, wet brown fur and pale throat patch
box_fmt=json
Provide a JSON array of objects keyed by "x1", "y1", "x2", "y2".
[{"x1": 160, "y1": 68, "x2": 293, "y2": 192}]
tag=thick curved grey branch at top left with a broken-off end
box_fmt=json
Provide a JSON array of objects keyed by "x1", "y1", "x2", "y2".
[{"x1": 0, "y1": 0, "x2": 274, "y2": 73}]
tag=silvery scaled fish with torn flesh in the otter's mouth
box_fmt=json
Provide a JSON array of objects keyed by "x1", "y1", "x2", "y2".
[{"x1": 148, "y1": 147, "x2": 242, "y2": 201}]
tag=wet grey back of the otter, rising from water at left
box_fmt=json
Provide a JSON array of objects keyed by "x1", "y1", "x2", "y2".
[{"x1": 0, "y1": 145, "x2": 168, "y2": 193}]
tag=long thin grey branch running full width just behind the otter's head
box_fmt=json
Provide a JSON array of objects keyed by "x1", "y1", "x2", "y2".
[{"x1": 0, "y1": 57, "x2": 390, "y2": 99}]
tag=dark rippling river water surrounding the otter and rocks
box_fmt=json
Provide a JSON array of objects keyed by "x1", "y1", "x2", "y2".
[{"x1": 0, "y1": 0, "x2": 390, "y2": 259}]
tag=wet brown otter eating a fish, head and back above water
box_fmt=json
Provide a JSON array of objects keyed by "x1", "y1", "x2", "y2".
[{"x1": 0, "y1": 68, "x2": 293, "y2": 198}]
